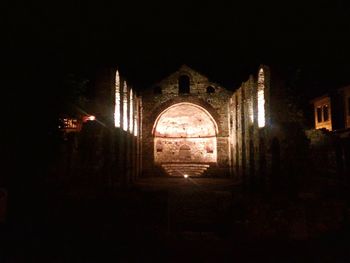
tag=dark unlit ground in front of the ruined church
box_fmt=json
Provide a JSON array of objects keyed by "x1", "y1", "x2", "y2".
[{"x1": 0, "y1": 178, "x2": 350, "y2": 263}]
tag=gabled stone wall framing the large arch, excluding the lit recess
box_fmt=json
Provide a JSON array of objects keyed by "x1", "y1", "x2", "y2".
[{"x1": 142, "y1": 66, "x2": 231, "y2": 176}]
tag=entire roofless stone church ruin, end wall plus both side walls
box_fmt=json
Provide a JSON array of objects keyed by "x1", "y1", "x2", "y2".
[{"x1": 57, "y1": 65, "x2": 298, "y2": 190}]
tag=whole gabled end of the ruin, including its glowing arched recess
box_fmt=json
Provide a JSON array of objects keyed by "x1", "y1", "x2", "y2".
[{"x1": 142, "y1": 65, "x2": 231, "y2": 176}]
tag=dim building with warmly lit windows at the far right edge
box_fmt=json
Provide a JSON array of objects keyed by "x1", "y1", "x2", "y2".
[{"x1": 307, "y1": 86, "x2": 350, "y2": 180}]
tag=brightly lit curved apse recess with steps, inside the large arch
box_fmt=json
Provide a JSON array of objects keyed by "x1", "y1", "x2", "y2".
[{"x1": 153, "y1": 102, "x2": 218, "y2": 176}]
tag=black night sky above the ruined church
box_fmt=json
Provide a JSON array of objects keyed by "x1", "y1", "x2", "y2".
[{"x1": 3, "y1": 0, "x2": 350, "y2": 126}]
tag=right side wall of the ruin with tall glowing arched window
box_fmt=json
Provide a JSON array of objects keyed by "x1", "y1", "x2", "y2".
[{"x1": 229, "y1": 66, "x2": 270, "y2": 185}]
